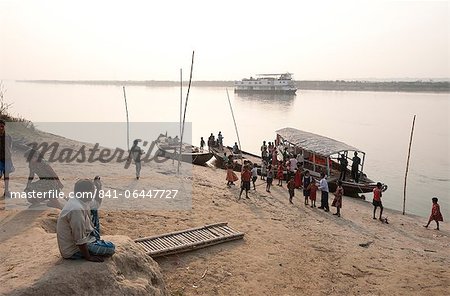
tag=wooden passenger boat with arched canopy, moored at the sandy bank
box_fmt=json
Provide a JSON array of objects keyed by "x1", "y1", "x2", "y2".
[{"x1": 276, "y1": 127, "x2": 387, "y2": 197}]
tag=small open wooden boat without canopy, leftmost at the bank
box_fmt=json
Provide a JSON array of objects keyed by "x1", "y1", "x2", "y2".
[{"x1": 155, "y1": 134, "x2": 213, "y2": 165}]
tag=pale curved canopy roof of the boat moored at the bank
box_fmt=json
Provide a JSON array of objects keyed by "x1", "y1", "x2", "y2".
[{"x1": 276, "y1": 127, "x2": 364, "y2": 157}]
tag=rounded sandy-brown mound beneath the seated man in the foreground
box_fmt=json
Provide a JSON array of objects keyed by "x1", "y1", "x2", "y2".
[{"x1": 12, "y1": 236, "x2": 168, "y2": 296}]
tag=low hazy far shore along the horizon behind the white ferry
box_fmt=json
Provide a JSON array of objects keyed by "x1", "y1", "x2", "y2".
[{"x1": 17, "y1": 79, "x2": 450, "y2": 94}]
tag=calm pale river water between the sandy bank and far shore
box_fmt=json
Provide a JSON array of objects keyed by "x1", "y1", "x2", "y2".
[{"x1": 4, "y1": 81, "x2": 450, "y2": 219}]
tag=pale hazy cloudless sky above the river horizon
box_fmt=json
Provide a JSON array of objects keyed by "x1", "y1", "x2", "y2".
[{"x1": 0, "y1": 0, "x2": 450, "y2": 80}]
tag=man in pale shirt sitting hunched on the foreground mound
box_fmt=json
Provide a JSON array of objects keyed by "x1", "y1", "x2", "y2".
[{"x1": 56, "y1": 177, "x2": 115, "y2": 262}]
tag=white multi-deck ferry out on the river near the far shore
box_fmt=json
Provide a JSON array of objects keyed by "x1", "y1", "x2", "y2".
[{"x1": 234, "y1": 73, "x2": 297, "y2": 94}]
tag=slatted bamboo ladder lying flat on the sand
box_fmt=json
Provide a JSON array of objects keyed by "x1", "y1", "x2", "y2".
[{"x1": 135, "y1": 222, "x2": 244, "y2": 258}]
